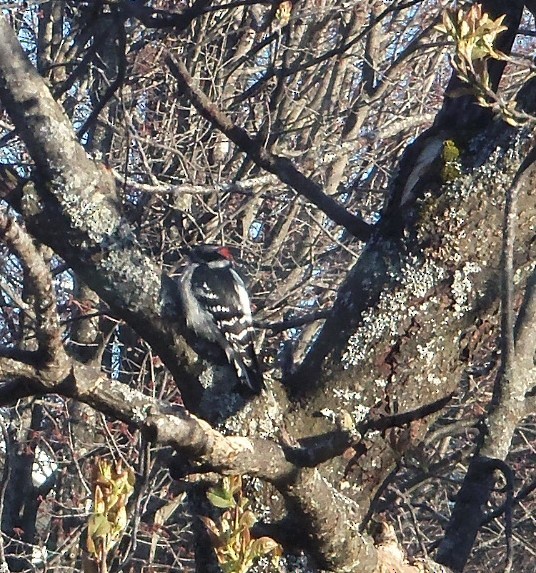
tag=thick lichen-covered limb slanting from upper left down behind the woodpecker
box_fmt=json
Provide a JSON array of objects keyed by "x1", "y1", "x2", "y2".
[{"x1": 0, "y1": 18, "x2": 201, "y2": 408}]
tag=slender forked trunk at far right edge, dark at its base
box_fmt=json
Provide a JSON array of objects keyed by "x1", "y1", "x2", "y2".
[{"x1": 437, "y1": 144, "x2": 536, "y2": 572}]
